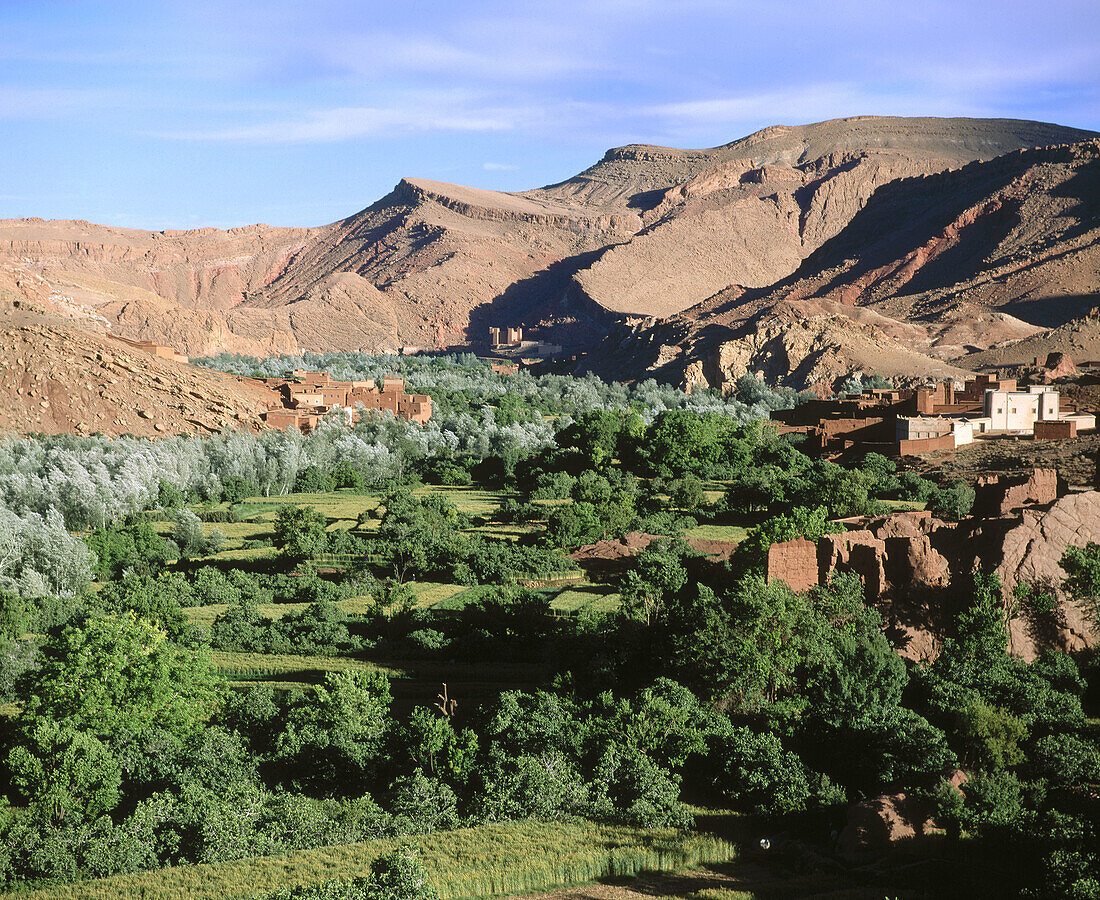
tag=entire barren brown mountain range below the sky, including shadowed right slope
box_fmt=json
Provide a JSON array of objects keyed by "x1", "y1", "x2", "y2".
[{"x1": 0, "y1": 117, "x2": 1097, "y2": 383}]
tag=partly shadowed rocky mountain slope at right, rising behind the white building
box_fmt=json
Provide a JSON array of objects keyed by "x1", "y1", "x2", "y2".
[{"x1": 597, "y1": 140, "x2": 1100, "y2": 386}]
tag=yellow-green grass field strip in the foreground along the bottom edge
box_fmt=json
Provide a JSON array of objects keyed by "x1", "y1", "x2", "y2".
[{"x1": 0, "y1": 821, "x2": 736, "y2": 900}]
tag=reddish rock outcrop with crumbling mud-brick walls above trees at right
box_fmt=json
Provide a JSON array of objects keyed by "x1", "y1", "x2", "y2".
[{"x1": 767, "y1": 484, "x2": 1100, "y2": 659}]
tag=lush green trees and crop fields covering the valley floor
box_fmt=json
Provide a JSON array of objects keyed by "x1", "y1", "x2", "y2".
[{"x1": 0, "y1": 354, "x2": 1100, "y2": 900}]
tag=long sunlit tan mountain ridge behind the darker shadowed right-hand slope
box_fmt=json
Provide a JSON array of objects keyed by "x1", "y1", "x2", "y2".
[{"x1": 0, "y1": 117, "x2": 1095, "y2": 374}]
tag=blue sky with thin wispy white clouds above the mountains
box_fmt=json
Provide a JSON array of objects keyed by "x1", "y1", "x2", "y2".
[{"x1": 0, "y1": 0, "x2": 1100, "y2": 229}]
